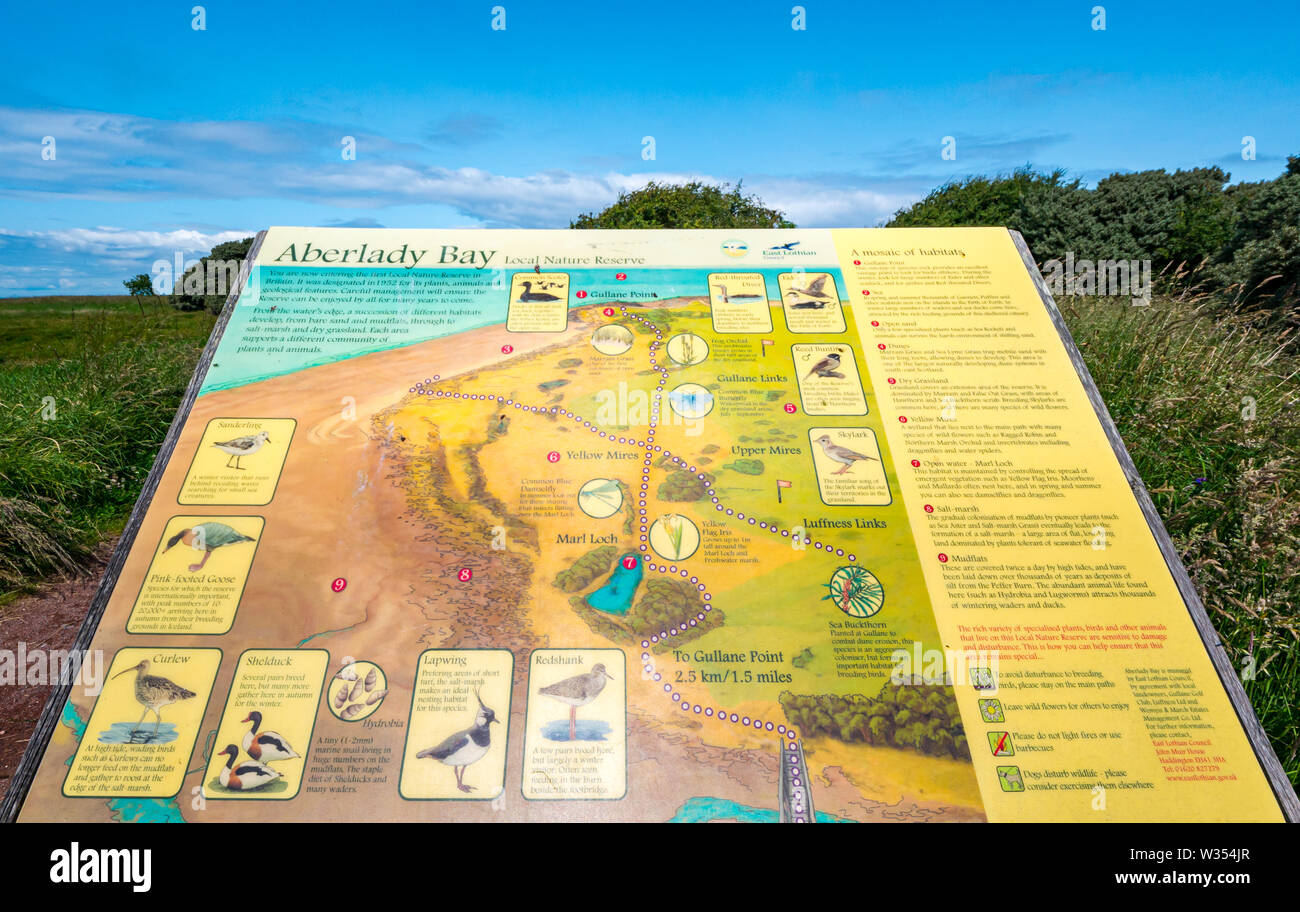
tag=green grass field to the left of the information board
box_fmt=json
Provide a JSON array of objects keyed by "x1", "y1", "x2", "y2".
[{"x1": 0, "y1": 296, "x2": 216, "y2": 602}]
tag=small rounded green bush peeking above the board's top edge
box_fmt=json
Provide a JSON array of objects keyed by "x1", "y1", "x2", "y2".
[{"x1": 569, "y1": 181, "x2": 794, "y2": 229}]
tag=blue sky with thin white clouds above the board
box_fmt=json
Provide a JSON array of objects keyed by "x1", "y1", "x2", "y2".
[{"x1": 0, "y1": 0, "x2": 1300, "y2": 296}]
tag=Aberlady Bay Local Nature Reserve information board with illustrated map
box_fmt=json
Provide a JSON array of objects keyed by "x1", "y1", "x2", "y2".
[{"x1": 22, "y1": 229, "x2": 1281, "y2": 821}]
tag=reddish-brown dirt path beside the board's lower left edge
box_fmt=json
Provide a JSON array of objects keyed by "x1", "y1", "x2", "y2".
[{"x1": 0, "y1": 538, "x2": 117, "y2": 796}]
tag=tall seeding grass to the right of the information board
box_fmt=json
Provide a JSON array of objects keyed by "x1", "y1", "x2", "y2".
[{"x1": 1062, "y1": 299, "x2": 1300, "y2": 782}]
